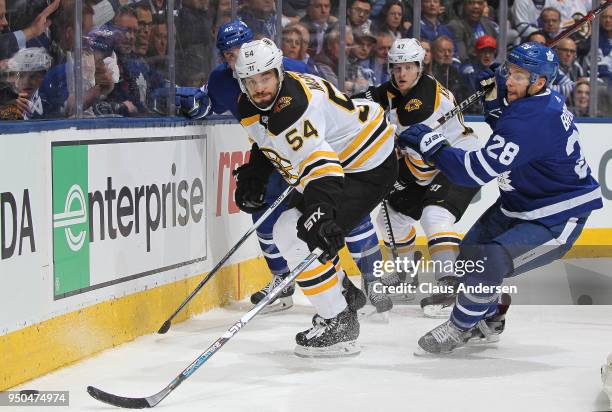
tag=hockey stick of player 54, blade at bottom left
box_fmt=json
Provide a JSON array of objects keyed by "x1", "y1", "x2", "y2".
[{"x1": 87, "y1": 248, "x2": 323, "y2": 409}]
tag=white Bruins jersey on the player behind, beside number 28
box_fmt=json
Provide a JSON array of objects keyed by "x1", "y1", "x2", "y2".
[{"x1": 378, "y1": 75, "x2": 480, "y2": 186}]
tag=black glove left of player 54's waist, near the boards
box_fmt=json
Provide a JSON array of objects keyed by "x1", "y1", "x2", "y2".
[{"x1": 233, "y1": 163, "x2": 268, "y2": 214}]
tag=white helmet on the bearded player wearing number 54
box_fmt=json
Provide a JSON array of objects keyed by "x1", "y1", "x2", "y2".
[{"x1": 234, "y1": 37, "x2": 283, "y2": 110}]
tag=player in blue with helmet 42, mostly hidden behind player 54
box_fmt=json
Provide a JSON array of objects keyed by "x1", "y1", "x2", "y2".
[{"x1": 177, "y1": 20, "x2": 382, "y2": 310}]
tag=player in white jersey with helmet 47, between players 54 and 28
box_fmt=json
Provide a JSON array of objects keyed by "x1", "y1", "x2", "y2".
[{"x1": 353, "y1": 39, "x2": 479, "y2": 317}]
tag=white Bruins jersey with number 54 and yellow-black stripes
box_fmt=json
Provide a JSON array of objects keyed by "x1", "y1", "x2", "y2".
[{"x1": 238, "y1": 72, "x2": 394, "y2": 192}]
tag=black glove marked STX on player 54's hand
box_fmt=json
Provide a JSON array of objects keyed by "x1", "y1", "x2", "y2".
[{"x1": 297, "y1": 203, "x2": 344, "y2": 263}]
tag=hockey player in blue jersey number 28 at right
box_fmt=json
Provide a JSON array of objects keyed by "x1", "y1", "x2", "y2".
[{"x1": 399, "y1": 42, "x2": 602, "y2": 353}]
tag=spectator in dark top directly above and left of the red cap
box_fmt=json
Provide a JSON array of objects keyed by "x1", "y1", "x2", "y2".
[{"x1": 450, "y1": 0, "x2": 497, "y2": 62}]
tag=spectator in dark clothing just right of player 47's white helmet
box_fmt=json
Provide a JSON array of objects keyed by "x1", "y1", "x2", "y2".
[{"x1": 432, "y1": 36, "x2": 471, "y2": 101}]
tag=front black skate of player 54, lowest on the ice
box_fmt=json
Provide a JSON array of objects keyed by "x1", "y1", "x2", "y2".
[{"x1": 295, "y1": 307, "x2": 361, "y2": 358}]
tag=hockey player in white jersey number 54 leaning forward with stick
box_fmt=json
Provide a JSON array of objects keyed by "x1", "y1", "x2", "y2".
[{"x1": 235, "y1": 38, "x2": 397, "y2": 356}]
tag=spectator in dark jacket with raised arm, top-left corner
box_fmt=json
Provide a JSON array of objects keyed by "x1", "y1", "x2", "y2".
[{"x1": 0, "y1": 0, "x2": 60, "y2": 60}]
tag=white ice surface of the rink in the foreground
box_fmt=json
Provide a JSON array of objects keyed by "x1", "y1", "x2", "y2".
[{"x1": 16, "y1": 292, "x2": 612, "y2": 412}]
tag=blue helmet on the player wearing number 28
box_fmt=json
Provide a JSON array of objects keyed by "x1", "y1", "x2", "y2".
[{"x1": 502, "y1": 41, "x2": 559, "y2": 87}]
